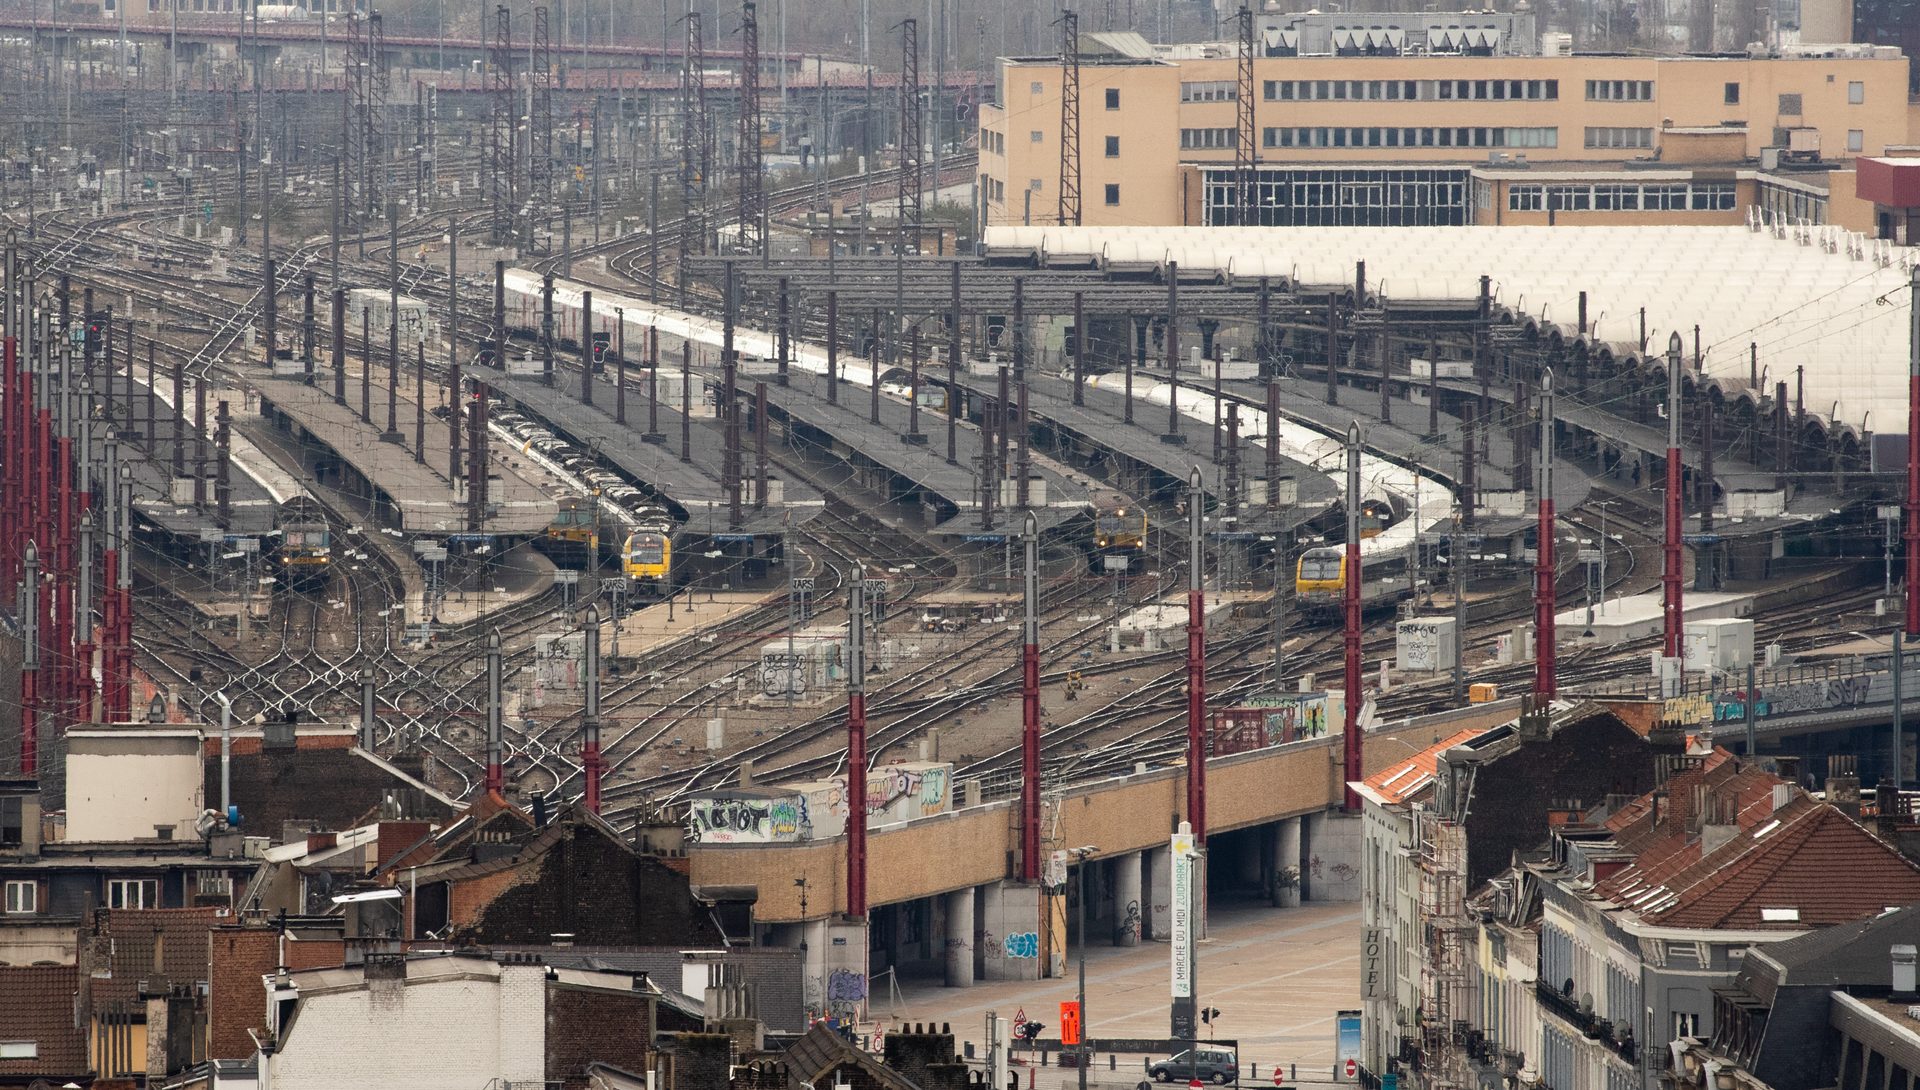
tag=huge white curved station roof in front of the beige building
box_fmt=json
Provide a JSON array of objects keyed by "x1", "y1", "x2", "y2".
[{"x1": 985, "y1": 223, "x2": 1916, "y2": 436}]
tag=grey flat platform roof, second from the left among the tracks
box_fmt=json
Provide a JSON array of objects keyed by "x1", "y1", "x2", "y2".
[{"x1": 259, "y1": 378, "x2": 559, "y2": 535}]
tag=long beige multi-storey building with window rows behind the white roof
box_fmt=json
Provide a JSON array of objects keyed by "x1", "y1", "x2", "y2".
[{"x1": 979, "y1": 38, "x2": 1914, "y2": 230}]
